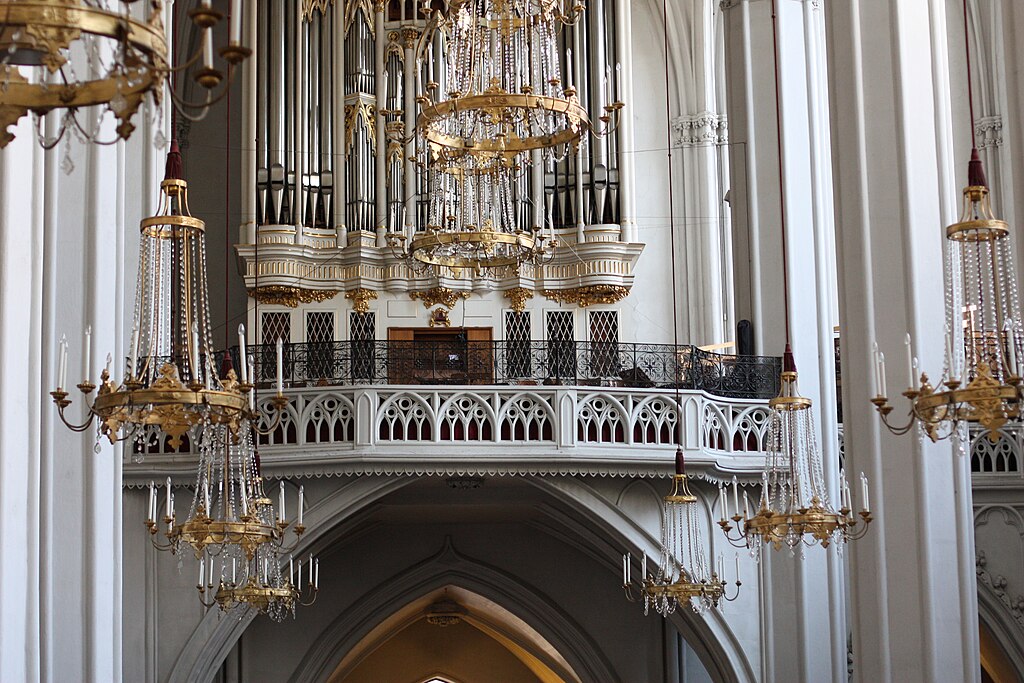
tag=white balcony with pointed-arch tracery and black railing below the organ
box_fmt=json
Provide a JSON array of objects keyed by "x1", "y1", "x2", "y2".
[{"x1": 119, "y1": 341, "x2": 779, "y2": 483}]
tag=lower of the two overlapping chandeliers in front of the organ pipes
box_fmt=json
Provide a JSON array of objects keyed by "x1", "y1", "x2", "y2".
[{"x1": 387, "y1": 155, "x2": 558, "y2": 278}]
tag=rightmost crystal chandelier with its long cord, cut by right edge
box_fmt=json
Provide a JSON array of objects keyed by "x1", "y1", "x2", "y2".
[{"x1": 871, "y1": 0, "x2": 1024, "y2": 444}]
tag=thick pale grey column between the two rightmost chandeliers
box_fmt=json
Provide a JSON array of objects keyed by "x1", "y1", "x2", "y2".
[{"x1": 827, "y1": 0, "x2": 980, "y2": 683}]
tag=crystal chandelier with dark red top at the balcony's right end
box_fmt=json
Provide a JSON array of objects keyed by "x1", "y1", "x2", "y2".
[{"x1": 718, "y1": 346, "x2": 871, "y2": 551}]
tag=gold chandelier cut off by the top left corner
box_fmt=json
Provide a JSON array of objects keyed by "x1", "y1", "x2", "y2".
[{"x1": 0, "y1": 0, "x2": 251, "y2": 150}]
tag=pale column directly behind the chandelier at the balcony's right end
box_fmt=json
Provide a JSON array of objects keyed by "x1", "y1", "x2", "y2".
[{"x1": 722, "y1": 0, "x2": 847, "y2": 683}]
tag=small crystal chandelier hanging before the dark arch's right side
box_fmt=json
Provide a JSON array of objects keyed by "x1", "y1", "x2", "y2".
[{"x1": 623, "y1": 450, "x2": 742, "y2": 616}]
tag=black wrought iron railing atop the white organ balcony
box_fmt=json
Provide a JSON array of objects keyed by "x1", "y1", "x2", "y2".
[{"x1": 231, "y1": 340, "x2": 781, "y2": 399}]
